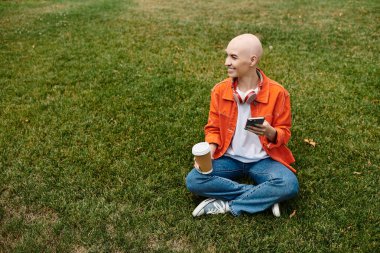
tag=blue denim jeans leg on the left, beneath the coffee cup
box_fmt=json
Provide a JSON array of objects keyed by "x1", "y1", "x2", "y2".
[{"x1": 186, "y1": 156, "x2": 248, "y2": 201}]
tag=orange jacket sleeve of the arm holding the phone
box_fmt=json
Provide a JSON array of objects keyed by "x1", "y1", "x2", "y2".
[{"x1": 269, "y1": 90, "x2": 292, "y2": 149}]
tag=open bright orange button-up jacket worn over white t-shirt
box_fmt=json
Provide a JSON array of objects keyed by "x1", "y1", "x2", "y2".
[{"x1": 205, "y1": 70, "x2": 296, "y2": 172}]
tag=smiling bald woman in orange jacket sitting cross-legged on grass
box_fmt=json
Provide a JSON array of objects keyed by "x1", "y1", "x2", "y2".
[{"x1": 186, "y1": 34, "x2": 299, "y2": 217}]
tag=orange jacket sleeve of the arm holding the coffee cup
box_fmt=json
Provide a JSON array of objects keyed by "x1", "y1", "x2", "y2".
[{"x1": 204, "y1": 87, "x2": 222, "y2": 147}]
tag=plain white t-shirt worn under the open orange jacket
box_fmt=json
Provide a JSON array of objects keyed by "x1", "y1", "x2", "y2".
[{"x1": 225, "y1": 88, "x2": 269, "y2": 163}]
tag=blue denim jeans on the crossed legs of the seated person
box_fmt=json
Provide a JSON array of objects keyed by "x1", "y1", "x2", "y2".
[{"x1": 186, "y1": 156, "x2": 299, "y2": 216}]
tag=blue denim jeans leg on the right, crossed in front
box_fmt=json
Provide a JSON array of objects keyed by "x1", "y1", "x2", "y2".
[{"x1": 230, "y1": 158, "x2": 299, "y2": 215}]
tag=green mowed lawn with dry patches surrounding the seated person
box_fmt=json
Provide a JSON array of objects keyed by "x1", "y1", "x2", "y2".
[{"x1": 0, "y1": 0, "x2": 380, "y2": 253}]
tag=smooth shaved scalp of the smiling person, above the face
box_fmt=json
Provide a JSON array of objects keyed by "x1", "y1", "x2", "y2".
[{"x1": 227, "y1": 33, "x2": 263, "y2": 62}]
